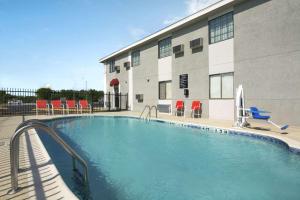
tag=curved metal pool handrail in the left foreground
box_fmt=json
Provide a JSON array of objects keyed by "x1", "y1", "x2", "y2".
[{"x1": 10, "y1": 119, "x2": 88, "y2": 193}]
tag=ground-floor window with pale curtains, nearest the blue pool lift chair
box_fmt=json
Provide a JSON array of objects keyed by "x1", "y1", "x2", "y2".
[{"x1": 209, "y1": 73, "x2": 233, "y2": 99}]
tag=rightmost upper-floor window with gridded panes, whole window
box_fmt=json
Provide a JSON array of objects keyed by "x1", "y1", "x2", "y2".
[{"x1": 209, "y1": 12, "x2": 233, "y2": 44}]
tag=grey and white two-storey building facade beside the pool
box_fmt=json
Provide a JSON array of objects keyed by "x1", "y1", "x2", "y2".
[{"x1": 100, "y1": 0, "x2": 300, "y2": 125}]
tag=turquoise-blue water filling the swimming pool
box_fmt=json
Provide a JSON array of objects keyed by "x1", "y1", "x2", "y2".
[{"x1": 40, "y1": 117, "x2": 300, "y2": 200}]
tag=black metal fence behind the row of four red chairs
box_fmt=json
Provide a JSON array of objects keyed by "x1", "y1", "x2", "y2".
[{"x1": 0, "y1": 88, "x2": 128, "y2": 117}]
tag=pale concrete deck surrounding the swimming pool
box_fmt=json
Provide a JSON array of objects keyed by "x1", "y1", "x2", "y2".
[{"x1": 0, "y1": 112, "x2": 300, "y2": 199}]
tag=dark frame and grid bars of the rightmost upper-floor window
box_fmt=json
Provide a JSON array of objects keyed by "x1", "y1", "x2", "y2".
[{"x1": 208, "y1": 11, "x2": 234, "y2": 44}]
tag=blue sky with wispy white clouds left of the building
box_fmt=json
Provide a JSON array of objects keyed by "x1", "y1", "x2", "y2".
[{"x1": 0, "y1": 0, "x2": 217, "y2": 90}]
